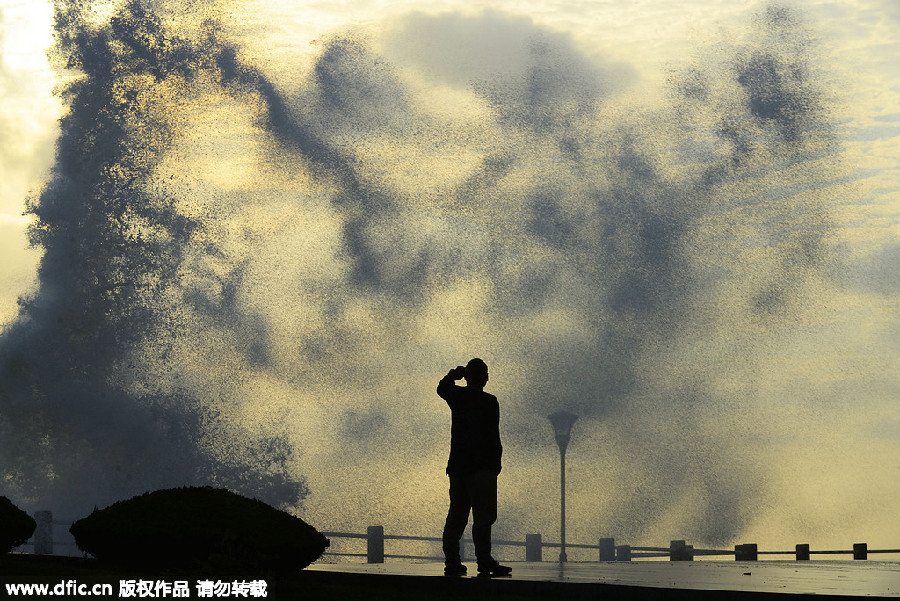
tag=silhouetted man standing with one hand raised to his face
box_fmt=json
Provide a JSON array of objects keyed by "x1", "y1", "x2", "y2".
[{"x1": 437, "y1": 359, "x2": 512, "y2": 577}]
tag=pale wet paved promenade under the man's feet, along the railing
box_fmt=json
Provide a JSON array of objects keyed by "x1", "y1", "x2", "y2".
[{"x1": 307, "y1": 560, "x2": 900, "y2": 599}]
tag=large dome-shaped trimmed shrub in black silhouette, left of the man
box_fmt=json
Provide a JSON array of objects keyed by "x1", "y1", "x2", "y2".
[{"x1": 69, "y1": 486, "x2": 329, "y2": 574}]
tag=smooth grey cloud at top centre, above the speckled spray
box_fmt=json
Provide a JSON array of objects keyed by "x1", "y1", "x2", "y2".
[{"x1": 387, "y1": 11, "x2": 634, "y2": 131}]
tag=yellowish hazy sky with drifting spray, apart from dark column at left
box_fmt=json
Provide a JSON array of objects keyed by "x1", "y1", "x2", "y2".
[{"x1": 0, "y1": 0, "x2": 900, "y2": 548}]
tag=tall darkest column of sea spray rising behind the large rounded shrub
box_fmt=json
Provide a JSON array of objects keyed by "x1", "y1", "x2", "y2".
[{"x1": 0, "y1": 2, "x2": 306, "y2": 518}]
